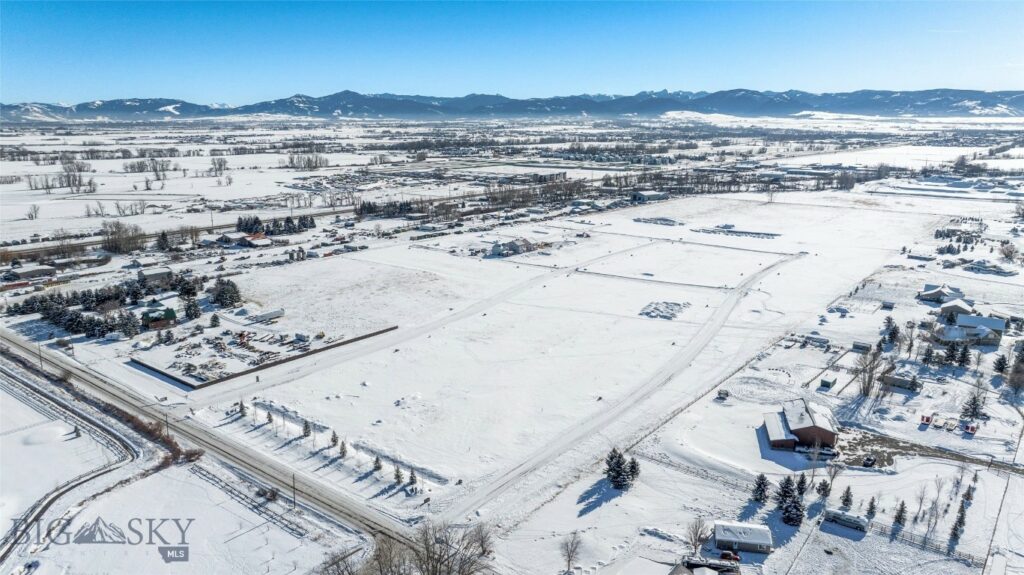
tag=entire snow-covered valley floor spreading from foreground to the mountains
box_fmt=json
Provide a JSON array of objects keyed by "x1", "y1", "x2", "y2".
[{"x1": 0, "y1": 118, "x2": 1024, "y2": 575}]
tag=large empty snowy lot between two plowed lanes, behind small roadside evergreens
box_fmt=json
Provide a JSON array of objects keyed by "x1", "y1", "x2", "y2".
[{"x1": 248, "y1": 275, "x2": 714, "y2": 480}]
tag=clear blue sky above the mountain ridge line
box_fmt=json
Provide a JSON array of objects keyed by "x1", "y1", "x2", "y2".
[{"x1": 0, "y1": 0, "x2": 1024, "y2": 104}]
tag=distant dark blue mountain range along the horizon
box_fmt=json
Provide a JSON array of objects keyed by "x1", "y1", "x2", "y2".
[{"x1": 0, "y1": 89, "x2": 1024, "y2": 123}]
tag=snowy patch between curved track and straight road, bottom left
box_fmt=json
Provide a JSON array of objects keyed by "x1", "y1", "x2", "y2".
[{"x1": 23, "y1": 460, "x2": 364, "y2": 574}]
